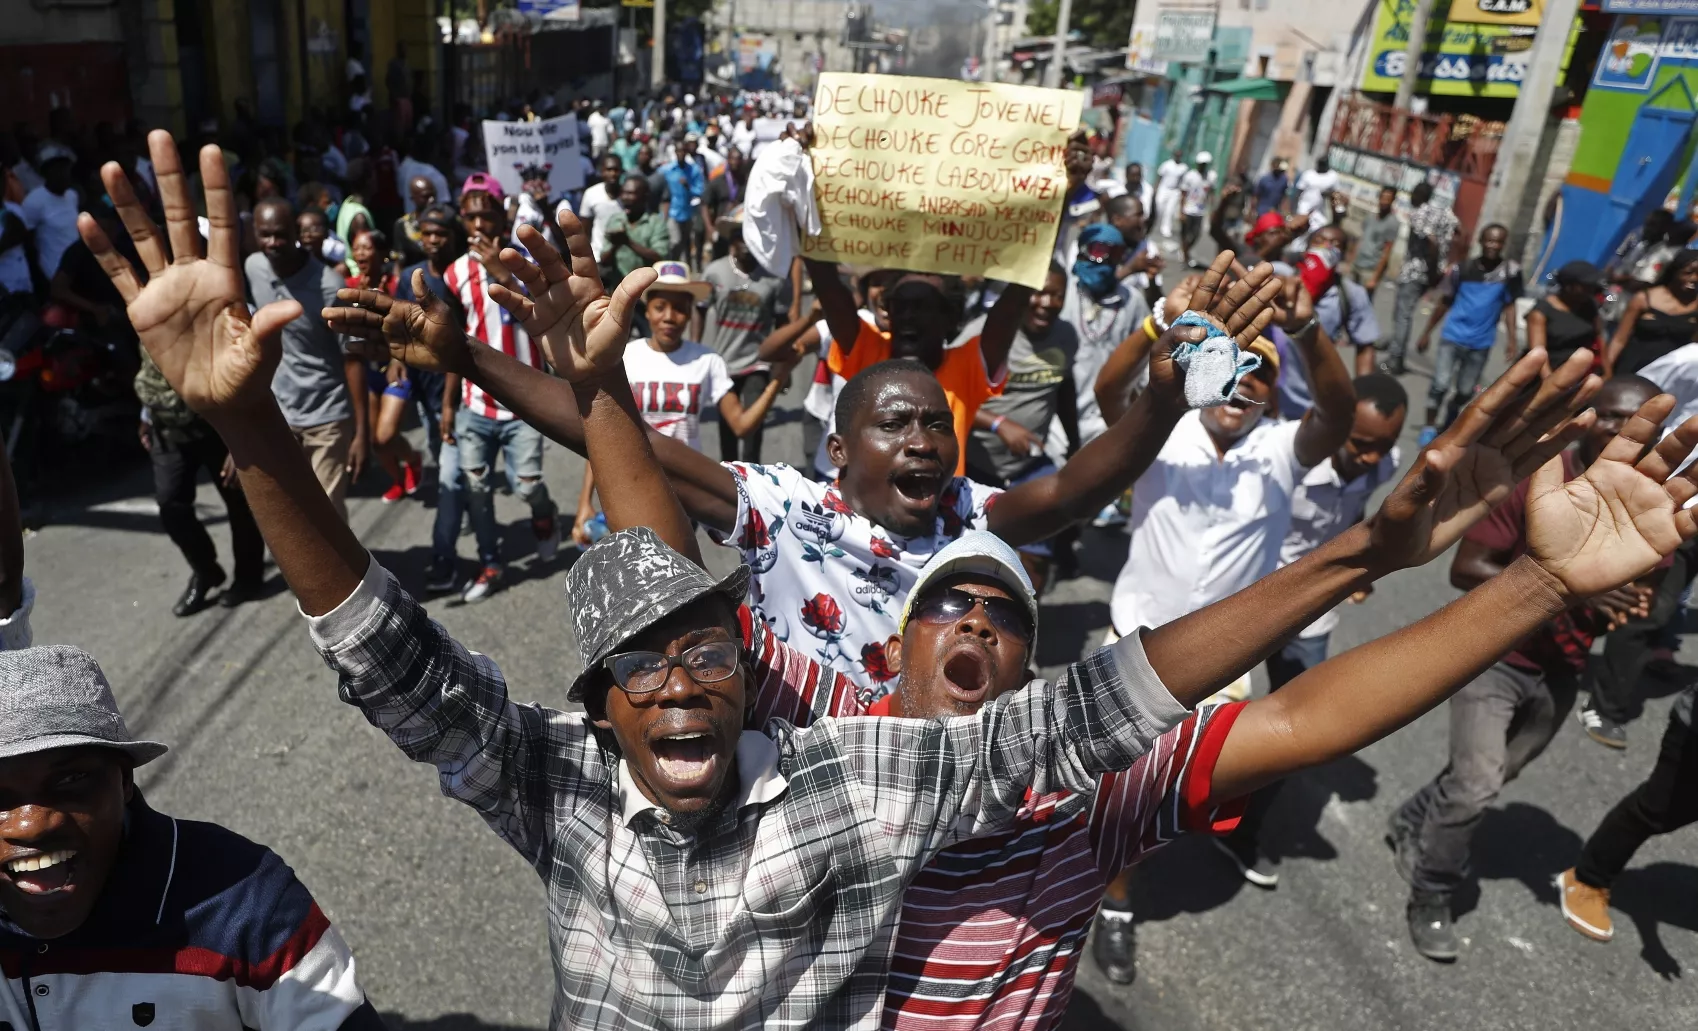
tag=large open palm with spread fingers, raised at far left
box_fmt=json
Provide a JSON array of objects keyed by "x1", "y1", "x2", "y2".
[{"x1": 76, "y1": 129, "x2": 301, "y2": 416}]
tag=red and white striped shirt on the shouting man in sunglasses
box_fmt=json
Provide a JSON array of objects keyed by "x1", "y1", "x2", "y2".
[{"x1": 742, "y1": 606, "x2": 1245, "y2": 1031}]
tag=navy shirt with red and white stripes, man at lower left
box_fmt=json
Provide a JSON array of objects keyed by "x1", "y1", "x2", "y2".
[{"x1": 0, "y1": 790, "x2": 384, "y2": 1031}]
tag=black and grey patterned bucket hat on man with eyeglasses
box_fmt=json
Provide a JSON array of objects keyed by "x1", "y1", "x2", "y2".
[{"x1": 565, "y1": 527, "x2": 749, "y2": 701}]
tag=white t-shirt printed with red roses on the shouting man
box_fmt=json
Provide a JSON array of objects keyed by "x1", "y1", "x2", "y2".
[{"x1": 713, "y1": 462, "x2": 1002, "y2": 701}]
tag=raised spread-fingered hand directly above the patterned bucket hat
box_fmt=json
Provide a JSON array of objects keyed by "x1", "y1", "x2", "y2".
[{"x1": 489, "y1": 209, "x2": 655, "y2": 382}]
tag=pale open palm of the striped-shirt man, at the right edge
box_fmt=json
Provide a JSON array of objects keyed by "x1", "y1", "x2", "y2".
[{"x1": 1527, "y1": 394, "x2": 1698, "y2": 600}]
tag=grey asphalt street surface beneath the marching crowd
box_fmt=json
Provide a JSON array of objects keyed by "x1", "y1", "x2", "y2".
[{"x1": 25, "y1": 264, "x2": 1698, "y2": 1031}]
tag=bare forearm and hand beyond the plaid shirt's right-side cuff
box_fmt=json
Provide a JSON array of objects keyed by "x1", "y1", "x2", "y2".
[{"x1": 1144, "y1": 352, "x2": 1601, "y2": 705}]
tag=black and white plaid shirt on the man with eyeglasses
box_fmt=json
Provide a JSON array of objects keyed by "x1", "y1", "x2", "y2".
[{"x1": 311, "y1": 561, "x2": 1185, "y2": 1028}]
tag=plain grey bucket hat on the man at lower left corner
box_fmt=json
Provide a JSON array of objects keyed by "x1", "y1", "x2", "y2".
[{"x1": 0, "y1": 644, "x2": 166, "y2": 766}]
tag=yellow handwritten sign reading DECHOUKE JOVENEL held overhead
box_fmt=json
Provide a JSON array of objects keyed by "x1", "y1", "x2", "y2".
[{"x1": 801, "y1": 73, "x2": 1080, "y2": 287}]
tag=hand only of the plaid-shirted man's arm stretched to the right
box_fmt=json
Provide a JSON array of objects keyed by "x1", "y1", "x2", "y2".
[{"x1": 1370, "y1": 352, "x2": 1601, "y2": 567}]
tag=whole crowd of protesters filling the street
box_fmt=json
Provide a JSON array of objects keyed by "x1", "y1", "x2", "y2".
[{"x1": 0, "y1": 68, "x2": 1698, "y2": 1029}]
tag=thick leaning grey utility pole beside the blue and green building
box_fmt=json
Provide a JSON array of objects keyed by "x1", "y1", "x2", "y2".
[{"x1": 1479, "y1": 0, "x2": 1579, "y2": 255}]
